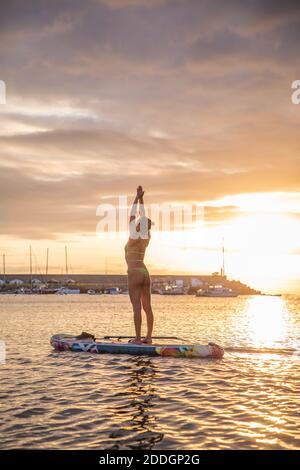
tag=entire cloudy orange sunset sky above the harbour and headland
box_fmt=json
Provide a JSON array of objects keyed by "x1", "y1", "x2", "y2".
[{"x1": 0, "y1": 0, "x2": 300, "y2": 292}]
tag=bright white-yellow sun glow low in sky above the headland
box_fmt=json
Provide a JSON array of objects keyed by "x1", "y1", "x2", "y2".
[{"x1": 151, "y1": 193, "x2": 300, "y2": 292}]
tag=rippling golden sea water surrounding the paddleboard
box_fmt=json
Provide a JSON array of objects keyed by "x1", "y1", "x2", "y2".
[{"x1": 0, "y1": 295, "x2": 300, "y2": 449}]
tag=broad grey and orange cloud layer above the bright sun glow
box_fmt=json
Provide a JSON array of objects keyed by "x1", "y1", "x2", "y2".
[{"x1": 0, "y1": 0, "x2": 300, "y2": 237}]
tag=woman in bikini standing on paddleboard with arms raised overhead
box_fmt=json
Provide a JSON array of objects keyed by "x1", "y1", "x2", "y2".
[{"x1": 125, "y1": 186, "x2": 153, "y2": 344}]
